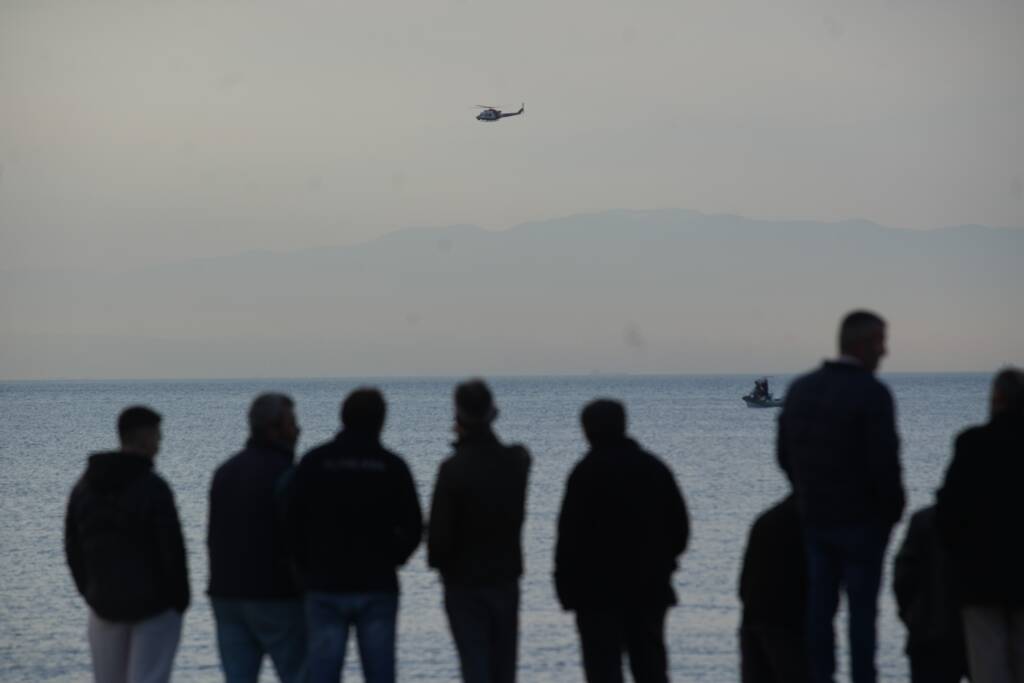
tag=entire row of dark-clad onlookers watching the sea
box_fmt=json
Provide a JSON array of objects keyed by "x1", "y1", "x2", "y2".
[{"x1": 65, "y1": 311, "x2": 1024, "y2": 683}]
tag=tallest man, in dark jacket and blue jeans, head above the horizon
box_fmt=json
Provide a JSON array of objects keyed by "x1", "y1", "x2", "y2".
[{"x1": 778, "y1": 311, "x2": 904, "y2": 683}]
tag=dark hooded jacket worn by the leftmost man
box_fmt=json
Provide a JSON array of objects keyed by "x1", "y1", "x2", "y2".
[{"x1": 65, "y1": 452, "x2": 189, "y2": 622}]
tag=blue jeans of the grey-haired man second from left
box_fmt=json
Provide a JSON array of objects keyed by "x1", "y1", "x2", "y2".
[{"x1": 210, "y1": 598, "x2": 306, "y2": 683}]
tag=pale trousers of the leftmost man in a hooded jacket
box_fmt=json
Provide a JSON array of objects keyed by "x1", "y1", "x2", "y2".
[{"x1": 89, "y1": 609, "x2": 181, "y2": 683}]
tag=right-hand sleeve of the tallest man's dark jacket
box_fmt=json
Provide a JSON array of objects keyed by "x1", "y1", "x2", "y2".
[{"x1": 865, "y1": 385, "x2": 905, "y2": 524}]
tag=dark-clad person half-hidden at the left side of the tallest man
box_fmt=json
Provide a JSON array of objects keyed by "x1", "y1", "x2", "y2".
[{"x1": 739, "y1": 494, "x2": 810, "y2": 683}]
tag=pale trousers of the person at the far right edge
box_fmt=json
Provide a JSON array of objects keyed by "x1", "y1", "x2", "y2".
[{"x1": 964, "y1": 605, "x2": 1024, "y2": 683}]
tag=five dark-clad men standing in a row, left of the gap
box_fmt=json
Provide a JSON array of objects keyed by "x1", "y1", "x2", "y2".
[{"x1": 66, "y1": 380, "x2": 689, "y2": 683}]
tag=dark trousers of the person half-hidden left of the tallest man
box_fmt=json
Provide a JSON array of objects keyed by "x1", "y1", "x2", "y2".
[{"x1": 739, "y1": 626, "x2": 811, "y2": 683}]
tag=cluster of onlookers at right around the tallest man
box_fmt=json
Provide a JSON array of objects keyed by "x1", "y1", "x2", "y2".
[{"x1": 739, "y1": 311, "x2": 1024, "y2": 683}]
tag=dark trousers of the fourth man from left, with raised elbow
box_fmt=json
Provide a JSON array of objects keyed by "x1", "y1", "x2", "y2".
[{"x1": 444, "y1": 581, "x2": 519, "y2": 683}]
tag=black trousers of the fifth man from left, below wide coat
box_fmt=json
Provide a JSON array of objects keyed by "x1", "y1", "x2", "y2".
[{"x1": 577, "y1": 607, "x2": 669, "y2": 683}]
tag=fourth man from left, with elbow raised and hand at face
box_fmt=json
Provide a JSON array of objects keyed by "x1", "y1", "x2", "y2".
[{"x1": 427, "y1": 380, "x2": 529, "y2": 683}]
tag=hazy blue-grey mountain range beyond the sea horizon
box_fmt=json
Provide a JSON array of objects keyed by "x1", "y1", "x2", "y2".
[{"x1": 0, "y1": 210, "x2": 1024, "y2": 378}]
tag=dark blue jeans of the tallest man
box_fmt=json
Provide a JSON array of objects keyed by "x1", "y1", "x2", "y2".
[{"x1": 804, "y1": 524, "x2": 892, "y2": 683}]
